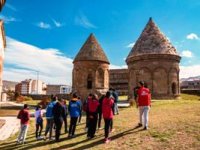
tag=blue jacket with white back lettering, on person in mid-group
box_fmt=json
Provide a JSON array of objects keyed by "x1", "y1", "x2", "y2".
[{"x1": 68, "y1": 99, "x2": 81, "y2": 117}]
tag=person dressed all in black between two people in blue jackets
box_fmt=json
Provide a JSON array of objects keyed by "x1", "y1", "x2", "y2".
[{"x1": 53, "y1": 99, "x2": 65, "y2": 142}]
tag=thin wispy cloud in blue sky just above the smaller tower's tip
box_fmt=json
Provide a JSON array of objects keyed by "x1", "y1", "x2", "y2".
[{"x1": 75, "y1": 13, "x2": 97, "y2": 29}]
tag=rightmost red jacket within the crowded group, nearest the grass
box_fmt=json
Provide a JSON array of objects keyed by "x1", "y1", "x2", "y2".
[{"x1": 102, "y1": 97, "x2": 114, "y2": 119}]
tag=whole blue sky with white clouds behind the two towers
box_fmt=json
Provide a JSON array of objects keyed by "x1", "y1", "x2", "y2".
[{"x1": 0, "y1": 0, "x2": 200, "y2": 84}]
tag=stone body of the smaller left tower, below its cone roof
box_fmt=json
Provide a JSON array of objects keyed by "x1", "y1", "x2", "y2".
[{"x1": 72, "y1": 61, "x2": 109, "y2": 99}]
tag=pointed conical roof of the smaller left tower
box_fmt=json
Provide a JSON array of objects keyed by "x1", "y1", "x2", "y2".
[{"x1": 74, "y1": 34, "x2": 110, "y2": 64}]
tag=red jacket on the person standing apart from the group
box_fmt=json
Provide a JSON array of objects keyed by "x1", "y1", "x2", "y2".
[{"x1": 137, "y1": 87, "x2": 151, "y2": 106}]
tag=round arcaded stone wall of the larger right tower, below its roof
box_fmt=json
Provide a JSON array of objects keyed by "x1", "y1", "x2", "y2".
[{"x1": 128, "y1": 54, "x2": 180, "y2": 98}]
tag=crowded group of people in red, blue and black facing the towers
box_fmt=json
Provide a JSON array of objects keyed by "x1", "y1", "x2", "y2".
[{"x1": 17, "y1": 91, "x2": 119, "y2": 143}]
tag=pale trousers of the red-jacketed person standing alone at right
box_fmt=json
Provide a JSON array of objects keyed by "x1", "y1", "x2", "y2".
[{"x1": 139, "y1": 106, "x2": 150, "y2": 127}]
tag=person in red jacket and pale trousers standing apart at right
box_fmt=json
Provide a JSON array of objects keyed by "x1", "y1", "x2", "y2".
[{"x1": 136, "y1": 81, "x2": 151, "y2": 130}]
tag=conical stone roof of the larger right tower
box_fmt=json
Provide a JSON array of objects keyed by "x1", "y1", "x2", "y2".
[{"x1": 127, "y1": 18, "x2": 178, "y2": 59}]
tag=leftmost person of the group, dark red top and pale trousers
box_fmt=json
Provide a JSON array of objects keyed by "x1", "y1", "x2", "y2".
[{"x1": 17, "y1": 104, "x2": 30, "y2": 144}]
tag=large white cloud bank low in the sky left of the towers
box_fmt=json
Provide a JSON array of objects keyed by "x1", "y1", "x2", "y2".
[{"x1": 3, "y1": 37, "x2": 73, "y2": 84}]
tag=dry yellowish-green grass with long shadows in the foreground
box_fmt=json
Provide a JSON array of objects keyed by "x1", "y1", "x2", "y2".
[{"x1": 0, "y1": 95, "x2": 200, "y2": 150}]
